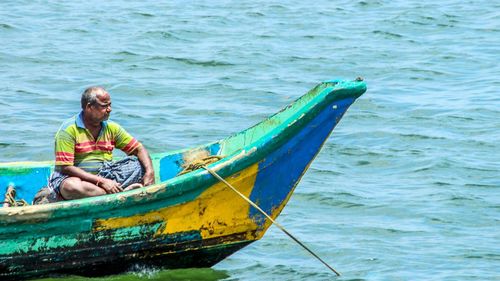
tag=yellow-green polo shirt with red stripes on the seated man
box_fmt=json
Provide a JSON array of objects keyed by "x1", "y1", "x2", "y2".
[{"x1": 55, "y1": 111, "x2": 141, "y2": 174}]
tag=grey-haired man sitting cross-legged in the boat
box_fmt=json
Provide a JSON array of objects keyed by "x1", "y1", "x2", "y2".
[{"x1": 49, "y1": 87, "x2": 154, "y2": 200}]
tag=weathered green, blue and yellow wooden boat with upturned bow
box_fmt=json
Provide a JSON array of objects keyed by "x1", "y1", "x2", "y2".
[{"x1": 0, "y1": 79, "x2": 366, "y2": 280}]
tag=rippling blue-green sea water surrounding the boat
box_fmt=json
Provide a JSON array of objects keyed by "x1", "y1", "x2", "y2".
[{"x1": 0, "y1": 0, "x2": 500, "y2": 281}]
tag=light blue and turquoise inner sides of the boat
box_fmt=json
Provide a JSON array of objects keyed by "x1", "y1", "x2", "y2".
[{"x1": 0, "y1": 82, "x2": 333, "y2": 207}]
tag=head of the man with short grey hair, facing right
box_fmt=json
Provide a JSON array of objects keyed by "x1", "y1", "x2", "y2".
[{"x1": 81, "y1": 87, "x2": 111, "y2": 122}]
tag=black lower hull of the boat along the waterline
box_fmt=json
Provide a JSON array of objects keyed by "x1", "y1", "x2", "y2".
[{"x1": 0, "y1": 235, "x2": 252, "y2": 280}]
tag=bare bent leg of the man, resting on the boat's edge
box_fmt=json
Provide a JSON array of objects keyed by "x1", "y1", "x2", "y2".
[{"x1": 59, "y1": 177, "x2": 106, "y2": 200}]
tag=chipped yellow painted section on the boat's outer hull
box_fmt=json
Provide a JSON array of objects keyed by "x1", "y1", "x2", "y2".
[{"x1": 94, "y1": 164, "x2": 263, "y2": 240}]
